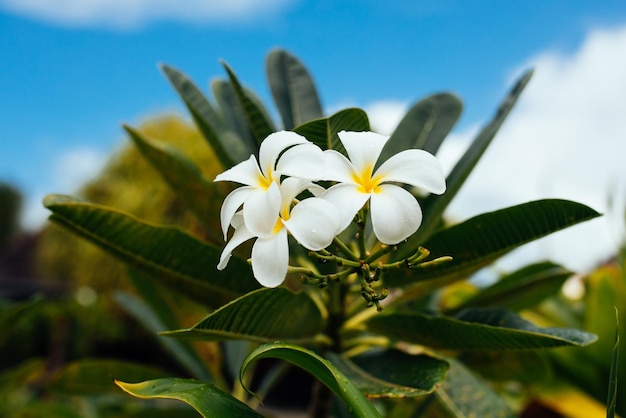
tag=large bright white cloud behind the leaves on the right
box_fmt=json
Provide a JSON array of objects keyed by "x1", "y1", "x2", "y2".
[{"x1": 356, "y1": 27, "x2": 626, "y2": 270}]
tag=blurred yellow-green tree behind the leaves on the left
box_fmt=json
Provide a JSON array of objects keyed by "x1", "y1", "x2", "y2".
[{"x1": 38, "y1": 115, "x2": 223, "y2": 291}]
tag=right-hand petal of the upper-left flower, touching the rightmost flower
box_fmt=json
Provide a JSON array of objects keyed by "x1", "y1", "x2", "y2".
[{"x1": 276, "y1": 143, "x2": 324, "y2": 180}]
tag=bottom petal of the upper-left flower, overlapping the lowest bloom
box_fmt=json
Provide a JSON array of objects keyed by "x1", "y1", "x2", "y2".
[{"x1": 243, "y1": 183, "x2": 281, "y2": 237}]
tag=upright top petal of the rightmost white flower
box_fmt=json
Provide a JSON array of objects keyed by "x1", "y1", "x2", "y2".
[{"x1": 337, "y1": 131, "x2": 389, "y2": 173}]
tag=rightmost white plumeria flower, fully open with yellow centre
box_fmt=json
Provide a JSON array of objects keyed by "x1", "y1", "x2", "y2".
[{"x1": 322, "y1": 131, "x2": 446, "y2": 245}]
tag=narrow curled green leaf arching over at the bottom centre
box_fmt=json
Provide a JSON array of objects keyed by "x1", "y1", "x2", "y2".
[{"x1": 239, "y1": 342, "x2": 381, "y2": 418}]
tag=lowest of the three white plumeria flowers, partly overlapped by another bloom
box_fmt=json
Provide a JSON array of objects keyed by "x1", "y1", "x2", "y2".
[{"x1": 217, "y1": 177, "x2": 339, "y2": 287}]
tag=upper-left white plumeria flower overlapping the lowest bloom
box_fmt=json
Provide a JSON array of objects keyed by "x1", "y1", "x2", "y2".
[{"x1": 215, "y1": 131, "x2": 324, "y2": 240}]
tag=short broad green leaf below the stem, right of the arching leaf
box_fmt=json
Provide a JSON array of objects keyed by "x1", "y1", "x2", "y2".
[{"x1": 329, "y1": 350, "x2": 449, "y2": 398}]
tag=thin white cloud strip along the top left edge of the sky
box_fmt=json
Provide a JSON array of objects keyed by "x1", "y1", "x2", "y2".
[{"x1": 0, "y1": 0, "x2": 293, "y2": 28}]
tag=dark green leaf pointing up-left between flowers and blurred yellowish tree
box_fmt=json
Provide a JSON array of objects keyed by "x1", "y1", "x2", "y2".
[{"x1": 124, "y1": 126, "x2": 223, "y2": 242}]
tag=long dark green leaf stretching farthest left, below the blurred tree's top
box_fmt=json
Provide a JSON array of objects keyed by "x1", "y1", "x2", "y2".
[{"x1": 44, "y1": 195, "x2": 259, "y2": 307}]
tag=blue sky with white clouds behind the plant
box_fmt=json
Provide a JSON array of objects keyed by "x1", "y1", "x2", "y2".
[{"x1": 0, "y1": 0, "x2": 626, "y2": 268}]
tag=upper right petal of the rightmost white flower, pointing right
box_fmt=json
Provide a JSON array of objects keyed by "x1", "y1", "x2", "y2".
[{"x1": 374, "y1": 149, "x2": 446, "y2": 194}]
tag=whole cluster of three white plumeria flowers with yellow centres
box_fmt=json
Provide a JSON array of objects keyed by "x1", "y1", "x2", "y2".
[{"x1": 215, "y1": 131, "x2": 446, "y2": 287}]
